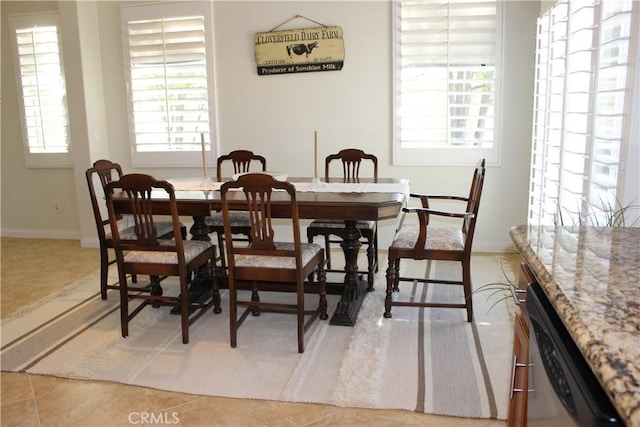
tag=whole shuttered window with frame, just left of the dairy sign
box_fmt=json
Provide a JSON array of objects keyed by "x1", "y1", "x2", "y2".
[{"x1": 121, "y1": 2, "x2": 216, "y2": 166}]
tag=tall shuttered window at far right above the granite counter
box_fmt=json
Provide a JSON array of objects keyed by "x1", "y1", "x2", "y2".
[{"x1": 528, "y1": 0, "x2": 640, "y2": 225}]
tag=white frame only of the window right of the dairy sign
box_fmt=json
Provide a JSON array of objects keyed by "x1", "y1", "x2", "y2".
[{"x1": 392, "y1": 0, "x2": 504, "y2": 166}]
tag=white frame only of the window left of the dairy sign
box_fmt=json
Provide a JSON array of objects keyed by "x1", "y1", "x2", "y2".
[{"x1": 121, "y1": 1, "x2": 217, "y2": 167}]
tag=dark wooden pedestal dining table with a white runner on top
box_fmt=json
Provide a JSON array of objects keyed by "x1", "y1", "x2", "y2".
[{"x1": 114, "y1": 178, "x2": 409, "y2": 326}]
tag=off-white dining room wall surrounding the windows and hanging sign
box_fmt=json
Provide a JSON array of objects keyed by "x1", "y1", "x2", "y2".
[{"x1": 2, "y1": 1, "x2": 540, "y2": 251}]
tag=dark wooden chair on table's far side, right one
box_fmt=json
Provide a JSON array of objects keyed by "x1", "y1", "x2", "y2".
[{"x1": 307, "y1": 148, "x2": 378, "y2": 291}]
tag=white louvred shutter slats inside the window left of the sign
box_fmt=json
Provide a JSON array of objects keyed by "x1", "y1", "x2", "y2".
[{"x1": 128, "y1": 16, "x2": 209, "y2": 151}]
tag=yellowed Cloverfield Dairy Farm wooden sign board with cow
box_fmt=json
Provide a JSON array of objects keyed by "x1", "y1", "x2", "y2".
[{"x1": 254, "y1": 26, "x2": 344, "y2": 76}]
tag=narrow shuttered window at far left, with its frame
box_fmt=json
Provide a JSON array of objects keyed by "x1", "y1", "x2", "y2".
[{"x1": 9, "y1": 13, "x2": 72, "y2": 167}]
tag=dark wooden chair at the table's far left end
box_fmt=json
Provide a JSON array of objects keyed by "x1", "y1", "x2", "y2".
[{"x1": 85, "y1": 159, "x2": 187, "y2": 299}]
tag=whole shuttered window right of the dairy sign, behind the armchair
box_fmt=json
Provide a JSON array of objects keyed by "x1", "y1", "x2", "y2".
[{"x1": 394, "y1": 0, "x2": 502, "y2": 165}]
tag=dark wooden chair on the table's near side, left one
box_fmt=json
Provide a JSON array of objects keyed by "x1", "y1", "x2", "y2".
[{"x1": 105, "y1": 173, "x2": 219, "y2": 344}]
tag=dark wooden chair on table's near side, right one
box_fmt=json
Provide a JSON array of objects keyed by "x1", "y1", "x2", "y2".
[{"x1": 221, "y1": 173, "x2": 329, "y2": 353}]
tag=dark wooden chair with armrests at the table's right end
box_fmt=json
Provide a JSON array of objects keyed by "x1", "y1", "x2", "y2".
[{"x1": 384, "y1": 159, "x2": 485, "y2": 322}]
